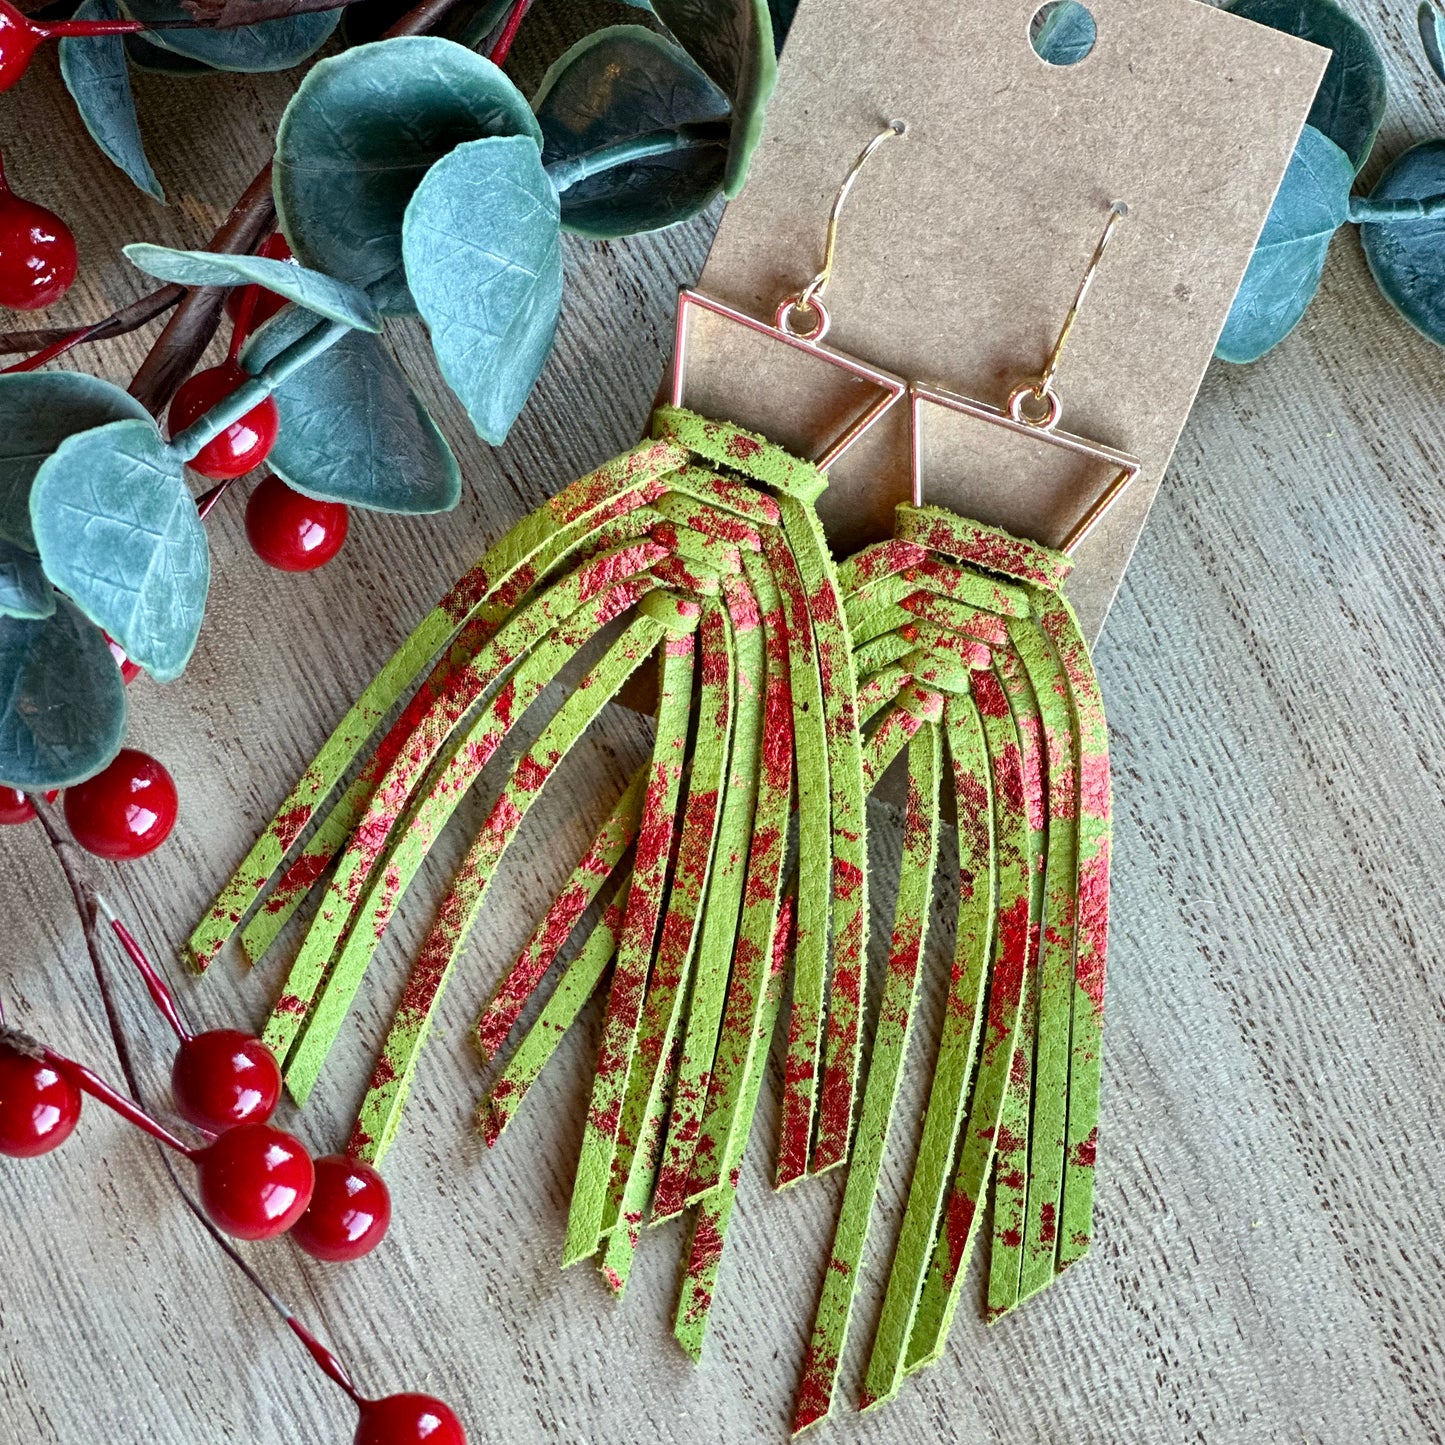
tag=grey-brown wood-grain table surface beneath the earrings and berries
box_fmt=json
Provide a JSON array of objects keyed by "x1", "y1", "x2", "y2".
[{"x1": 0, "y1": 0, "x2": 1445, "y2": 1445}]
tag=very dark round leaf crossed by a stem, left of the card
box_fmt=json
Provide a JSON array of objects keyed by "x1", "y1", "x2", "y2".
[{"x1": 532, "y1": 25, "x2": 730, "y2": 238}]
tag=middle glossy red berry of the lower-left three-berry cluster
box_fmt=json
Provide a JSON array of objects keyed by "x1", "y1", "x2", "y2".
[{"x1": 195, "y1": 1124, "x2": 316, "y2": 1240}]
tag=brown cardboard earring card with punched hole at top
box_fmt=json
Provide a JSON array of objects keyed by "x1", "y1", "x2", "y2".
[{"x1": 685, "y1": 0, "x2": 1328, "y2": 639}]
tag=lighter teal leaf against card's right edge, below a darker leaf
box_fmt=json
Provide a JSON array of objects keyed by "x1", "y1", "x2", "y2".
[{"x1": 1214, "y1": 126, "x2": 1354, "y2": 361}]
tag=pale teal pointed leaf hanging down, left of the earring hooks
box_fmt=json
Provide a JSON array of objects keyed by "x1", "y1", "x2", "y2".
[{"x1": 402, "y1": 136, "x2": 562, "y2": 447}]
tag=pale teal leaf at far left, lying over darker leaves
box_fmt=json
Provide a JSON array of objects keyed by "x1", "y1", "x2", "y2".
[{"x1": 30, "y1": 418, "x2": 211, "y2": 682}]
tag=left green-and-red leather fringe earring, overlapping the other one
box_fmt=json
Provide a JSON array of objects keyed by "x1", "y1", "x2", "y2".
[{"x1": 189, "y1": 126, "x2": 906, "y2": 1329}]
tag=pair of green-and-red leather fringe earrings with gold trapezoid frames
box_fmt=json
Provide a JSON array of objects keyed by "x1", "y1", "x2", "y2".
[{"x1": 188, "y1": 137, "x2": 1134, "y2": 1429}]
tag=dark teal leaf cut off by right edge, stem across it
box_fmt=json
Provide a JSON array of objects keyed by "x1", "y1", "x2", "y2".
[{"x1": 1360, "y1": 140, "x2": 1445, "y2": 345}]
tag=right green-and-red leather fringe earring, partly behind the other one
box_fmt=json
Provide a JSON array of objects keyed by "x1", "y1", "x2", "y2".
[{"x1": 793, "y1": 202, "x2": 1139, "y2": 1431}]
